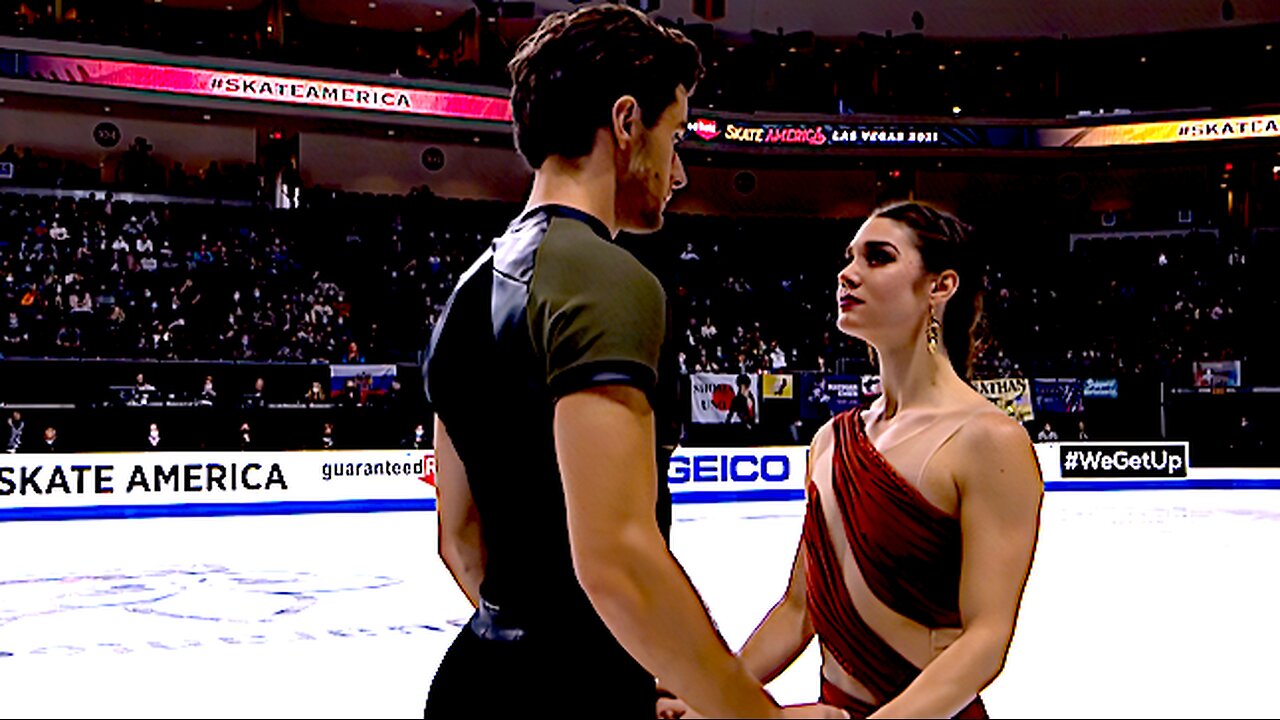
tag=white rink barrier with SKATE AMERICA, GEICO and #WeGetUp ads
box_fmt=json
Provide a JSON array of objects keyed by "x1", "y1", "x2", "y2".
[{"x1": 0, "y1": 442, "x2": 1280, "y2": 521}]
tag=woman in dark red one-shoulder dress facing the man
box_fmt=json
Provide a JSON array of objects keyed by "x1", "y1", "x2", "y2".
[{"x1": 659, "y1": 201, "x2": 1043, "y2": 717}]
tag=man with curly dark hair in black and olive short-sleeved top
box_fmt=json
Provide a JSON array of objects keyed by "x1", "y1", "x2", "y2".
[{"x1": 424, "y1": 4, "x2": 844, "y2": 717}]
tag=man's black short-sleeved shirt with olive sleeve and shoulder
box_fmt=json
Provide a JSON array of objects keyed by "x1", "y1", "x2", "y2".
[{"x1": 424, "y1": 205, "x2": 678, "y2": 630}]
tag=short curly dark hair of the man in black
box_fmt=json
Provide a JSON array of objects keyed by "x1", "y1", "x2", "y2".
[{"x1": 507, "y1": 4, "x2": 704, "y2": 169}]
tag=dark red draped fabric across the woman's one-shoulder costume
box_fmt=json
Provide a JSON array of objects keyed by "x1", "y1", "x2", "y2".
[{"x1": 804, "y1": 409, "x2": 970, "y2": 710}]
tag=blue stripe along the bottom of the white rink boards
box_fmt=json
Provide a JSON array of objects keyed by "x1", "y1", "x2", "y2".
[{"x1": 0, "y1": 478, "x2": 1280, "y2": 523}]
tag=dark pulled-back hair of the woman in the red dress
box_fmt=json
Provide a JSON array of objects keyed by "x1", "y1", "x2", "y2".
[{"x1": 872, "y1": 200, "x2": 983, "y2": 379}]
